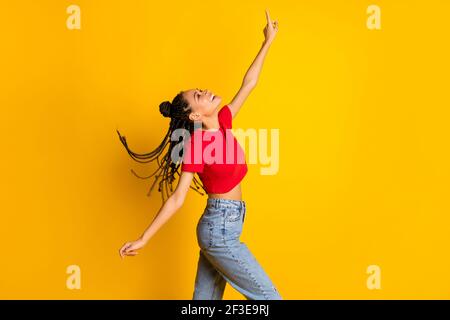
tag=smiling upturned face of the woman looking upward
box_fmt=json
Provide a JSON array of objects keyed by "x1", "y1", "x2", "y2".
[{"x1": 183, "y1": 88, "x2": 222, "y2": 121}]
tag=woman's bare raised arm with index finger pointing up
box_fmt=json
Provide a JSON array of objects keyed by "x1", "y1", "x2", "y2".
[{"x1": 228, "y1": 10, "x2": 278, "y2": 118}]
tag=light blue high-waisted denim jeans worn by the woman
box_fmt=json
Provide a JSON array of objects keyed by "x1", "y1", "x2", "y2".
[{"x1": 193, "y1": 198, "x2": 282, "y2": 300}]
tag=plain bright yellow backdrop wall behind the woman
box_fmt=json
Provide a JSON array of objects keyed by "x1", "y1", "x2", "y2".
[{"x1": 0, "y1": 0, "x2": 450, "y2": 299}]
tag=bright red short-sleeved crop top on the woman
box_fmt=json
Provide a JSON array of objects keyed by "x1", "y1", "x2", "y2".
[{"x1": 181, "y1": 105, "x2": 248, "y2": 193}]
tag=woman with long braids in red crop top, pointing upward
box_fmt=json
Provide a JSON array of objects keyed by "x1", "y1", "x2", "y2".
[{"x1": 119, "y1": 11, "x2": 282, "y2": 300}]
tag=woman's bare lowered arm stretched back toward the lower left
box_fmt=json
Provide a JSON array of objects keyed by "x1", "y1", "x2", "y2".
[{"x1": 119, "y1": 171, "x2": 194, "y2": 258}]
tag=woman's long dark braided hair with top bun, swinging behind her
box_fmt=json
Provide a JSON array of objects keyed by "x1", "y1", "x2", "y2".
[{"x1": 117, "y1": 91, "x2": 206, "y2": 202}]
